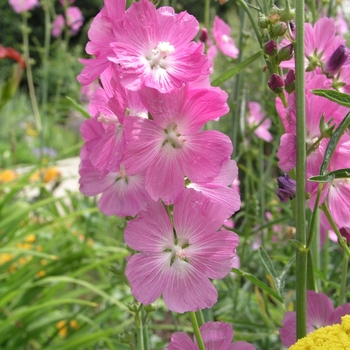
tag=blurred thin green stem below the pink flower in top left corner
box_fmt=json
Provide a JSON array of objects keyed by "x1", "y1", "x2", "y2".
[{"x1": 22, "y1": 12, "x2": 42, "y2": 133}]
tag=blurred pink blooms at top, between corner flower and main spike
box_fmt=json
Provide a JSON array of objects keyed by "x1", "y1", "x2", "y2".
[{"x1": 51, "y1": 1, "x2": 84, "y2": 38}]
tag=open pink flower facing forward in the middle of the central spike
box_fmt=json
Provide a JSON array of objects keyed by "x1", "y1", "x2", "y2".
[{"x1": 124, "y1": 86, "x2": 232, "y2": 204}]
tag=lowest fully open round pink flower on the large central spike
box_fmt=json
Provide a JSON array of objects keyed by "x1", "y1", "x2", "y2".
[{"x1": 125, "y1": 190, "x2": 238, "y2": 313}]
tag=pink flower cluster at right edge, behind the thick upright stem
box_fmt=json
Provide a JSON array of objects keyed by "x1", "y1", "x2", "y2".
[{"x1": 276, "y1": 18, "x2": 350, "y2": 235}]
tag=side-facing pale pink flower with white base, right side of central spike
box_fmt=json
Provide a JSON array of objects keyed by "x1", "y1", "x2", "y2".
[{"x1": 187, "y1": 160, "x2": 241, "y2": 217}]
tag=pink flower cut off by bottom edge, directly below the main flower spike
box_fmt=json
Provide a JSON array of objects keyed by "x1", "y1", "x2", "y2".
[{"x1": 166, "y1": 322, "x2": 255, "y2": 350}]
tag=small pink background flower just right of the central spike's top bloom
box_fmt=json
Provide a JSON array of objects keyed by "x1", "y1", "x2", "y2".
[{"x1": 213, "y1": 16, "x2": 239, "y2": 58}]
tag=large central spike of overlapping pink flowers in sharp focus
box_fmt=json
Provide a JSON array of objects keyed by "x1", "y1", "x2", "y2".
[{"x1": 78, "y1": 0, "x2": 240, "y2": 313}]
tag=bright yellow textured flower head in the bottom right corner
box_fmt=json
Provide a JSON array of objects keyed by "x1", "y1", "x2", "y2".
[{"x1": 289, "y1": 315, "x2": 350, "y2": 350}]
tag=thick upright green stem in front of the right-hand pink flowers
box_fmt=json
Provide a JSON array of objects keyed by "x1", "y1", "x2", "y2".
[{"x1": 295, "y1": 0, "x2": 307, "y2": 339}]
